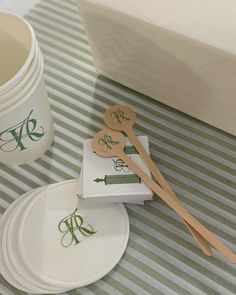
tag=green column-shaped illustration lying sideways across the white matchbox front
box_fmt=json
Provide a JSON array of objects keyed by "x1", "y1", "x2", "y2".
[{"x1": 94, "y1": 174, "x2": 141, "y2": 185}]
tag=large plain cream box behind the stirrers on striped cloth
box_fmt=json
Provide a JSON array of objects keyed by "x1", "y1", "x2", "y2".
[{"x1": 77, "y1": 0, "x2": 236, "y2": 135}]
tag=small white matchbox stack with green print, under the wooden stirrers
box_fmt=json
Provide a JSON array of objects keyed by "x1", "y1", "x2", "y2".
[{"x1": 77, "y1": 136, "x2": 153, "y2": 204}]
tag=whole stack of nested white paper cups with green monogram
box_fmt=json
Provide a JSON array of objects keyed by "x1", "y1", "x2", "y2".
[{"x1": 0, "y1": 12, "x2": 54, "y2": 165}]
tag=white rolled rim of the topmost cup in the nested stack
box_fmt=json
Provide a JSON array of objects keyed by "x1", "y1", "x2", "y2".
[{"x1": 0, "y1": 11, "x2": 37, "y2": 94}]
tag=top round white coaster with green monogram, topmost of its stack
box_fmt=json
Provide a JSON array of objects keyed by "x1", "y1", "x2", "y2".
[{"x1": 18, "y1": 180, "x2": 129, "y2": 288}]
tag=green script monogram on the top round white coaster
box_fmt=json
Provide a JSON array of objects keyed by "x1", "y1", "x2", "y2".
[{"x1": 58, "y1": 209, "x2": 96, "y2": 248}]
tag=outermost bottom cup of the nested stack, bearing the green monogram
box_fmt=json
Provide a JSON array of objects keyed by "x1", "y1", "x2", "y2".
[{"x1": 0, "y1": 57, "x2": 54, "y2": 165}]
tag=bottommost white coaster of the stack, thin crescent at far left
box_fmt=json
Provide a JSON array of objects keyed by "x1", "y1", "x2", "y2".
[{"x1": 0, "y1": 193, "x2": 31, "y2": 293}]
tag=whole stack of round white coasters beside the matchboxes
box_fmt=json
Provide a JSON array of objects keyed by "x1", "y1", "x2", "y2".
[{"x1": 0, "y1": 180, "x2": 129, "y2": 294}]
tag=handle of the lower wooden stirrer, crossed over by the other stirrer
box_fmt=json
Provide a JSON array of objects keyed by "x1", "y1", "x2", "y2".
[{"x1": 125, "y1": 128, "x2": 212, "y2": 256}]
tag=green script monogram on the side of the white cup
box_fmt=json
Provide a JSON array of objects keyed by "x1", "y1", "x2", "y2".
[{"x1": 0, "y1": 110, "x2": 46, "y2": 152}]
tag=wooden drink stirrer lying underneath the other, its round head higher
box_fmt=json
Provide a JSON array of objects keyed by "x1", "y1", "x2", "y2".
[{"x1": 104, "y1": 105, "x2": 212, "y2": 256}]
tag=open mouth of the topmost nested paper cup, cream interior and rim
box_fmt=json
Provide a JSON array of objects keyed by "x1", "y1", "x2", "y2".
[{"x1": 0, "y1": 12, "x2": 36, "y2": 95}]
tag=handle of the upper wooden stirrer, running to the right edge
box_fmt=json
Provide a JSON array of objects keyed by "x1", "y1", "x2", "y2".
[{"x1": 120, "y1": 150, "x2": 236, "y2": 263}]
